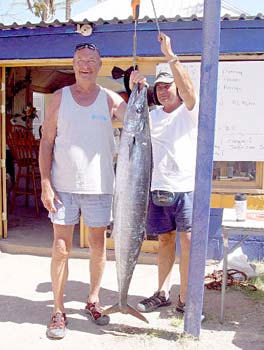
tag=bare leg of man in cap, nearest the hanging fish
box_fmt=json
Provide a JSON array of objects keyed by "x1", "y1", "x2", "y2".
[{"x1": 158, "y1": 231, "x2": 176, "y2": 298}]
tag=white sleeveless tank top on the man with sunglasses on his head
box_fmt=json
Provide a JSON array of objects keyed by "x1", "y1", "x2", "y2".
[{"x1": 52, "y1": 86, "x2": 114, "y2": 194}]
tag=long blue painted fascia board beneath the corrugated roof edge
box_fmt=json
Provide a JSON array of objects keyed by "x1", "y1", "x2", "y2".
[{"x1": 0, "y1": 19, "x2": 264, "y2": 60}]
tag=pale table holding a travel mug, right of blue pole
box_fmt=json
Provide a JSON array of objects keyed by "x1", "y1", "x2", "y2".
[{"x1": 220, "y1": 208, "x2": 264, "y2": 323}]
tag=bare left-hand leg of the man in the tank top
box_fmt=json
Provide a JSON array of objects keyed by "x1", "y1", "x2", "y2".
[{"x1": 51, "y1": 224, "x2": 74, "y2": 314}]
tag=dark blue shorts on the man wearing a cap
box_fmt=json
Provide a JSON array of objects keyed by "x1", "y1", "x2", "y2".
[{"x1": 147, "y1": 192, "x2": 193, "y2": 235}]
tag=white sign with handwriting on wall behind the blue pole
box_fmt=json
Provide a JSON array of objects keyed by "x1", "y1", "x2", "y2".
[{"x1": 180, "y1": 61, "x2": 264, "y2": 161}]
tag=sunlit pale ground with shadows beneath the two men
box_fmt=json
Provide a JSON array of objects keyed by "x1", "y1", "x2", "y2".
[{"x1": 0, "y1": 253, "x2": 264, "y2": 350}]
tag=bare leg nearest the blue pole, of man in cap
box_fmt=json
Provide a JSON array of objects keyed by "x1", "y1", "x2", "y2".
[{"x1": 180, "y1": 232, "x2": 191, "y2": 303}]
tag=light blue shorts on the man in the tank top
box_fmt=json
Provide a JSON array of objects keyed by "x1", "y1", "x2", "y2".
[{"x1": 49, "y1": 192, "x2": 113, "y2": 227}]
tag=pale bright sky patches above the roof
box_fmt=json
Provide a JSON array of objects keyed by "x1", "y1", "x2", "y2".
[{"x1": 0, "y1": 0, "x2": 264, "y2": 24}]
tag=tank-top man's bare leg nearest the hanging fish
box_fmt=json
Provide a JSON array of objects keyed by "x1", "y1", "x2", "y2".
[{"x1": 88, "y1": 227, "x2": 106, "y2": 303}]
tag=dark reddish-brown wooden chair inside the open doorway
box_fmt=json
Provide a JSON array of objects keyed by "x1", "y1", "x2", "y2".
[{"x1": 6, "y1": 125, "x2": 40, "y2": 216}]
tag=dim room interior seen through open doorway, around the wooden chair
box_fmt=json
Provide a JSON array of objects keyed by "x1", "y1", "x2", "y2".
[{"x1": 6, "y1": 65, "x2": 124, "y2": 244}]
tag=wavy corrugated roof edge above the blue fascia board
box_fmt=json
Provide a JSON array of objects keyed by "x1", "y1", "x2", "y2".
[{"x1": 0, "y1": 13, "x2": 264, "y2": 30}]
